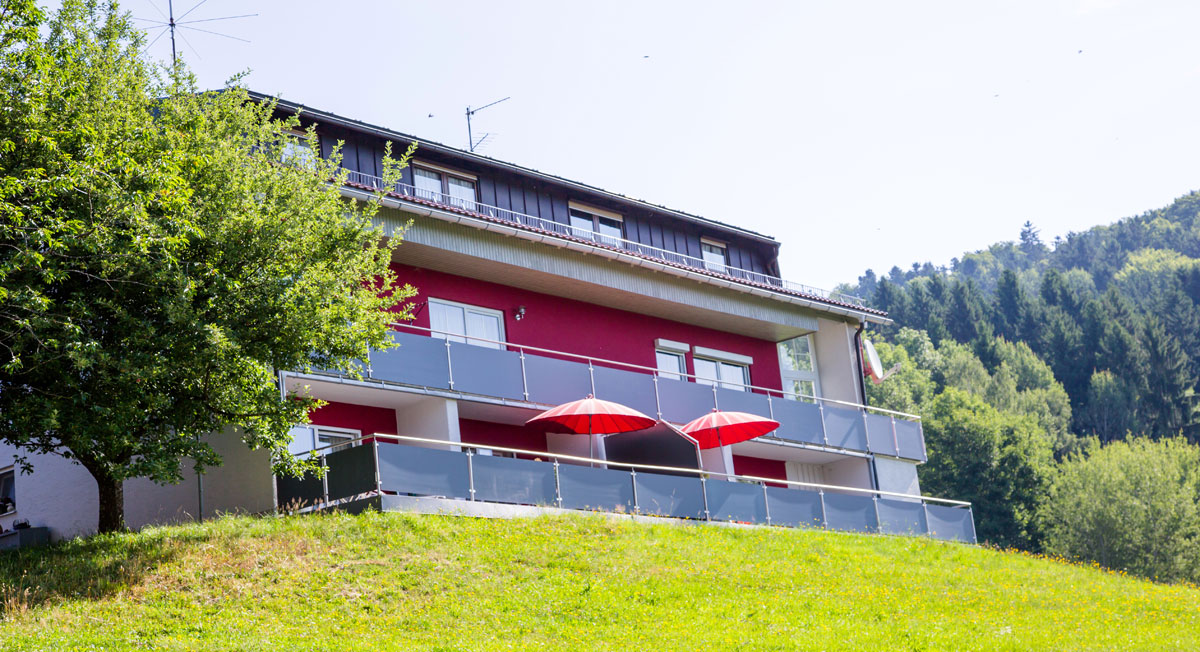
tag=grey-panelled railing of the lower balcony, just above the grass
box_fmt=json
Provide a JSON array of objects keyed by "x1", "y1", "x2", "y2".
[{"x1": 276, "y1": 435, "x2": 976, "y2": 543}]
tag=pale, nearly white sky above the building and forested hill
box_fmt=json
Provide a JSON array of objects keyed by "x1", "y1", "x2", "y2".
[{"x1": 122, "y1": 0, "x2": 1200, "y2": 288}]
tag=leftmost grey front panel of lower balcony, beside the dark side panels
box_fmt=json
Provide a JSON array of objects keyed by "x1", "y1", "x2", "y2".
[{"x1": 379, "y1": 444, "x2": 470, "y2": 498}]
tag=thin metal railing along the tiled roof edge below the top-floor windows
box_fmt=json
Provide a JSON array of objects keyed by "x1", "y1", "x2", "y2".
[{"x1": 346, "y1": 171, "x2": 866, "y2": 309}]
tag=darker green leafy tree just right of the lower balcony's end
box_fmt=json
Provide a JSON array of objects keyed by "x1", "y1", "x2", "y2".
[{"x1": 920, "y1": 388, "x2": 1052, "y2": 550}]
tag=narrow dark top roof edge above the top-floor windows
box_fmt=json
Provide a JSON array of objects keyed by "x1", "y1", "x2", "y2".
[{"x1": 248, "y1": 91, "x2": 779, "y2": 250}]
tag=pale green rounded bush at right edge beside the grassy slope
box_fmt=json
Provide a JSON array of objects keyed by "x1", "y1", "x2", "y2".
[{"x1": 1040, "y1": 438, "x2": 1200, "y2": 581}]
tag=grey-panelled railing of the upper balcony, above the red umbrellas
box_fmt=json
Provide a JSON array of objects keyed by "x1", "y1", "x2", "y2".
[{"x1": 290, "y1": 323, "x2": 926, "y2": 461}]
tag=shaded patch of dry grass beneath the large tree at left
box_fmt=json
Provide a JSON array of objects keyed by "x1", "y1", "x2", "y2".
[{"x1": 0, "y1": 531, "x2": 210, "y2": 620}]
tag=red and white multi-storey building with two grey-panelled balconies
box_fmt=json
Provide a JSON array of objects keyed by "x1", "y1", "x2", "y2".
[{"x1": 0, "y1": 96, "x2": 974, "y2": 540}]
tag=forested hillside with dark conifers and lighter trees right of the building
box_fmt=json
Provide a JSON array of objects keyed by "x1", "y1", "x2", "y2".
[{"x1": 841, "y1": 193, "x2": 1200, "y2": 581}]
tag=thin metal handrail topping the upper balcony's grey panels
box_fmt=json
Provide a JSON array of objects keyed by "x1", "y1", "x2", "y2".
[{"x1": 391, "y1": 322, "x2": 920, "y2": 421}]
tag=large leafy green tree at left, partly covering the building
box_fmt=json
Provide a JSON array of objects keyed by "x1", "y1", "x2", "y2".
[{"x1": 0, "y1": 0, "x2": 413, "y2": 532}]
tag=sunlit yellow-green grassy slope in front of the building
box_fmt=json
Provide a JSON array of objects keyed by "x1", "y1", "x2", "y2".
[{"x1": 0, "y1": 514, "x2": 1200, "y2": 651}]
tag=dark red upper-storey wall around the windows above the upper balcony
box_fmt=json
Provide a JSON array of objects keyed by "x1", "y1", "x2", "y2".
[{"x1": 394, "y1": 262, "x2": 781, "y2": 389}]
